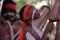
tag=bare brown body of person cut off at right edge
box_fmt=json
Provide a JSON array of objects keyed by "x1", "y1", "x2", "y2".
[{"x1": 50, "y1": 0, "x2": 60, "y2": 40}]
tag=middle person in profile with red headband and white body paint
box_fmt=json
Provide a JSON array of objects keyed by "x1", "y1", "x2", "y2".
[{"x1": 18, "y1": 5, "x2": 42, "y2": 40}]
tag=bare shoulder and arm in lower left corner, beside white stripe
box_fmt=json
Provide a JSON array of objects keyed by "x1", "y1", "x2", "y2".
[{"x1": 0, "y1": 15, "x2": 12, "y2": 40}]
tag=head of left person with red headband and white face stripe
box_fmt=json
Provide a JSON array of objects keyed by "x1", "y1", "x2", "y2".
[{"x1": 1, "y1": 0, "x2": 16, "y2": 24}]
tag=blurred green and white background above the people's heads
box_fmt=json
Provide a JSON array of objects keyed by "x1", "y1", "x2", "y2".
[{"x1": 13, "y1": 0, "x2": 56, "y2": 13}]
